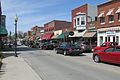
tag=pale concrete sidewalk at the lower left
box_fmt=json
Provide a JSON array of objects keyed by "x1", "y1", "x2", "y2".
[{"x1": 0, "y1": 56, "x2": 42, "y2": 80}]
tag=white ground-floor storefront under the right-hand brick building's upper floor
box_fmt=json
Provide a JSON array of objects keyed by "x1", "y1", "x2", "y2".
[{"x1": 97, "y1": 26, "x2": 120, "y2": 46}]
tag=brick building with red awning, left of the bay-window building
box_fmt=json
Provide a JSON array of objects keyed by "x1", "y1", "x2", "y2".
[{"x1": 41, "y1": 20, "x2": 72, "y2": 39}]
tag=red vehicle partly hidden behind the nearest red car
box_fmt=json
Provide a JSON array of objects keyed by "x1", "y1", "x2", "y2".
[{"x1": 93, "y1": 42, "x2": 118, "y2": 52}]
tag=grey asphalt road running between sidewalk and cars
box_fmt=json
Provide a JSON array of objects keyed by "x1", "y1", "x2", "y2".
[{"x1": 19, "y1": 47, "x2": 120, "y2": 80}]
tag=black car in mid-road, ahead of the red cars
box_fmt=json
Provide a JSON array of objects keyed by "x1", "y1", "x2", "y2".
[{"x1": 56, "y1": 43, "x2": 82, "y2": 55}]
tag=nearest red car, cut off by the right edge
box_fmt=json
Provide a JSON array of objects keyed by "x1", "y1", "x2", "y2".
[{"x1": 93, "y1": 46, "x2": 120, "y2": 64}]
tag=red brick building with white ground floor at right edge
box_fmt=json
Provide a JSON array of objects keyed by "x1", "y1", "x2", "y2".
[{"x1": 97, "y1": 0, "x2": 120, "y2": 46}]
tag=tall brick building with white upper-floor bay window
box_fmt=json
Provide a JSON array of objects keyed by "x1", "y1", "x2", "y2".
[{"x1": 69, "y1": 4, "x2": 97, "y2": 43}]
